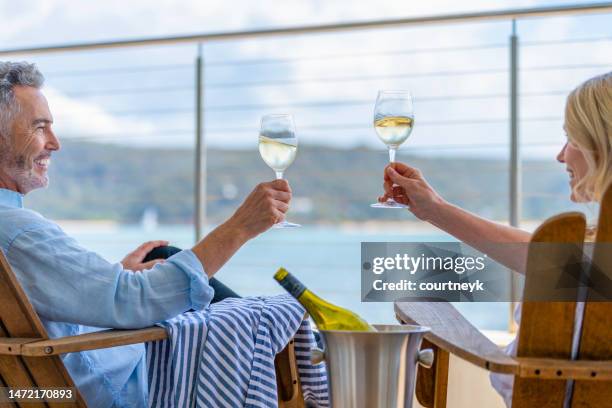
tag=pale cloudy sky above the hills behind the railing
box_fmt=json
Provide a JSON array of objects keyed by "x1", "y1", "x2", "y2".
[{"x1": 0, "y1": 0, "x2": 612, "y2": 158}]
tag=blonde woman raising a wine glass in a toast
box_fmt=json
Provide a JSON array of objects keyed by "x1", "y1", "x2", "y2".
[{"x1": 379, "y1": 72, "x2": 612, "y2": 406}]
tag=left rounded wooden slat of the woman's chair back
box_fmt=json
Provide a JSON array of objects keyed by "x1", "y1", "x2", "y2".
[{"x1": 512, "y1": 213, "x2": 586, "y2": 408}]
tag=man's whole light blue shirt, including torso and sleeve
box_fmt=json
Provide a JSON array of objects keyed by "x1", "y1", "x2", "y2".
[{"x1": 0, "y1": 188, "x2": 214, "y2": 408}]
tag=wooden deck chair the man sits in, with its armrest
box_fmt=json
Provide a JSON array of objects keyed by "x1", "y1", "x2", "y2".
[{"x1": 0, "y1": 251, "x2": 304, "y2": 408}]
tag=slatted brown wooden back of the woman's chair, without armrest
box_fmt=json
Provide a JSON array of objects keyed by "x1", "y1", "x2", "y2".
[{"x1": 512, "y1": 183, "x2": 612, "y2": 408}]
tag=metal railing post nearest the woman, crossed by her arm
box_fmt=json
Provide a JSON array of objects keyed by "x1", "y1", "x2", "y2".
[{"x1": 509, "y1": 20, "x2": 521, "y2": 331}]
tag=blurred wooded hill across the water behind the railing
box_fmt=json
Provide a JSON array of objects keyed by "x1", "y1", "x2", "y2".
[{"x1": 26, "y1": 141, "x2": 570, "y2": 223}]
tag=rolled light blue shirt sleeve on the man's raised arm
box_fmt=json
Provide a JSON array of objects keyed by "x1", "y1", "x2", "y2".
[{"x1": 7, "y1": 223, "x2": 214, "y2": 329}]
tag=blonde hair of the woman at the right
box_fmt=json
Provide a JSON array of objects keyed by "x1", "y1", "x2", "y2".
[{"x1": 565, "y1": 72, "x2": 612, "y2": 202}]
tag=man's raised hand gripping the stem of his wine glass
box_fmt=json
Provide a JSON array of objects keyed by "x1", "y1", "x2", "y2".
[{"x1": 226, "y1": 180, "x2": 291, "y2": 240}]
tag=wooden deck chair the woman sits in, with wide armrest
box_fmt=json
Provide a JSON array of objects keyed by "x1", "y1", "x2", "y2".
[{"x1": 395, "y1": 183, "x2": 612, "y2": 408}]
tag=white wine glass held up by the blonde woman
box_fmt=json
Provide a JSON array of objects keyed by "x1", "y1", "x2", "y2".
[{"x1": 371, "y1": 91, "x2": 414, "y2": 208}]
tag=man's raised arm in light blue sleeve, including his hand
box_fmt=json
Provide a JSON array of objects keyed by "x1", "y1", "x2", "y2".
[{"x1": 6, "y1": 180, "x2": 291, "y2": 329}]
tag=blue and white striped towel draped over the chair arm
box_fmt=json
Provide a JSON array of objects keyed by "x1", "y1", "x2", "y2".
[{"x1": 146, "y1": 295, "x2": 329, "y2": 408}]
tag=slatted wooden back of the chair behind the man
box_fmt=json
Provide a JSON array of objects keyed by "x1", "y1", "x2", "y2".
[{"x1": 0, "y1": 251, "x2": 87, "y2": 408}]
